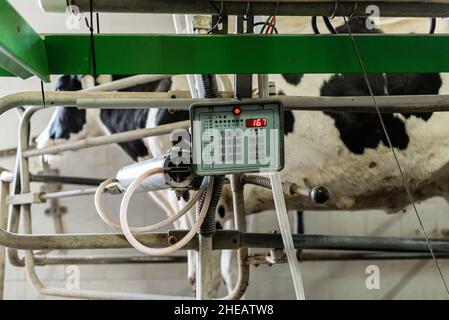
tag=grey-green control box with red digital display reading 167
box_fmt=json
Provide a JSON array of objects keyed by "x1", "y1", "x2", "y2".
[{"x1": 190, "y1": 100, "x2": 284, "y2": 176}]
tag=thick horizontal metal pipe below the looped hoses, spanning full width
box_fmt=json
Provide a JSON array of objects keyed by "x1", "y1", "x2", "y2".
[{"x1": 0, "y1": 229, "x2": 449, "y2": 253}]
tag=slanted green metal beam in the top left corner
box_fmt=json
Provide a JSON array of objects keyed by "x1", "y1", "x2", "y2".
[{"x1": 0, "y1": 0, "x2": 50, "y2": 82}]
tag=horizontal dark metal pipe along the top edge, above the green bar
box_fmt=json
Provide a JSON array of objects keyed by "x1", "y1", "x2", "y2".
[{"x1": 41, "y1": 0, "x2": 449, "y2": 17}]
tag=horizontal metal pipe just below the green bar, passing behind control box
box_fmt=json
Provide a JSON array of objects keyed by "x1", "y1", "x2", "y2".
[{"x1": 6, "y1": 91, "x2": 449, "y2": 115}]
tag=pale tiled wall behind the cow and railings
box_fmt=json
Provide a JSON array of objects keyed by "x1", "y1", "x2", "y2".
[{"x1": 0, "y1": 0, "x2": 449, "y2": 299}]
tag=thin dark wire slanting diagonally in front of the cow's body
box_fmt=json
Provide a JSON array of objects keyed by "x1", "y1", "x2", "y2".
[{"x1": 343, "y1": 16, "x2": 449, "y2": 296}]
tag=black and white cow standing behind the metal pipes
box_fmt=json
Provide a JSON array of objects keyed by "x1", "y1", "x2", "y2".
[{"x1": 39, "y1": 19, "x2": 449, "y2": 296}]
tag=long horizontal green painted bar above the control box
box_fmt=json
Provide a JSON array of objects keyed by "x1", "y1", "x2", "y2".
[{"x1": 45, "y1": 35, "x2": 449, "y2": 74}]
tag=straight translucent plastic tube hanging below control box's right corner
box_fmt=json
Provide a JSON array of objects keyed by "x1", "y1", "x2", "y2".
[{"x1": 270, "y1": 172, "x2": 306, "y2": 300}]
